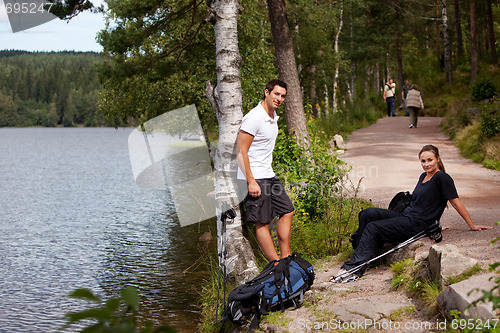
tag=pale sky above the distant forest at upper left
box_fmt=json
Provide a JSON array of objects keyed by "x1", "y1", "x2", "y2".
[{"x1": 0, "y1": 0, "x2": 105, "y2": 52}]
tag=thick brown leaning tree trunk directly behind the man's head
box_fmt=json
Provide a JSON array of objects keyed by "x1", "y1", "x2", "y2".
[{"x1": 267, "y1": 0, "x2": 310, "y2": 150}]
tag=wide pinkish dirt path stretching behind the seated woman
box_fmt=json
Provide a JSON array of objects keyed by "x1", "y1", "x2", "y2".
[{"x1": 340, "y1": 117, "x2": 500, "y2": 267}]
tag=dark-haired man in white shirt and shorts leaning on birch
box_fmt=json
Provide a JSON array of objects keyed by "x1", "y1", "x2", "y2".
[{"x1": 237, "y1": 80, "x2": 295, "y2": 261}]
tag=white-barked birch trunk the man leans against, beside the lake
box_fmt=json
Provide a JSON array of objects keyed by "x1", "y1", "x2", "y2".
[{"x1": 205, "y1": 0, "x2": 259, "y2": 284}]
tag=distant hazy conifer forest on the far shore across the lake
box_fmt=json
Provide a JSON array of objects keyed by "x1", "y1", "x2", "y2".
[{"x1": 0, "y1": 50, "x2": 107, "y2": 127}]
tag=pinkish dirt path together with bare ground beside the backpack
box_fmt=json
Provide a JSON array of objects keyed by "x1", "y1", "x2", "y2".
[{"x1": 262, "y1": 117, "x2": 500, "y2": 333}]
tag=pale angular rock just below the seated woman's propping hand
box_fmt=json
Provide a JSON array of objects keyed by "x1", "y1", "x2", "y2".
[{"x1": 429, "y1": 244, "x2": 477, "y2": 288}]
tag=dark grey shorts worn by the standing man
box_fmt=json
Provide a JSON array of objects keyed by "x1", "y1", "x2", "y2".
[{"x1": 245, "y1": 177, "x2": 295, "y2": 224}]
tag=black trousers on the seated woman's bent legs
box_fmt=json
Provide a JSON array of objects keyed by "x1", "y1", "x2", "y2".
[{"x1": 342, "y1": 208, "x2": 427, "y2": 274}]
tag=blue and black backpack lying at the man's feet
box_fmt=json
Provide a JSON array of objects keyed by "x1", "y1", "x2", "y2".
[{"x1": 223, "y1": 253, "x2": 314, "y2": 331}]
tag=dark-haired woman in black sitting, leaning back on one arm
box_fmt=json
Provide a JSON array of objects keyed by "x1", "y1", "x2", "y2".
[{"x1": 330, "y1": 145, "x2": 491, "y2": 283}]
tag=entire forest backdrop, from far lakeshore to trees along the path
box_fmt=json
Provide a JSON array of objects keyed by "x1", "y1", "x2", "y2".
[{"x1": 0, "y1": 0, "x2": 500, "y2": 132}]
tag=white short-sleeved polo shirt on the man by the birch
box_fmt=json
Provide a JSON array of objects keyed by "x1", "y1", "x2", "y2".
[{"x1": 238, "y1": 102, "x2": 279, "y2": 179}]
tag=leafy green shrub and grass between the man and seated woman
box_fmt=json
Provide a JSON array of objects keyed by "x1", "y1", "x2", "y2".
[{"x1": 274, "y1": 127, "x2": 367, "y2": 258}]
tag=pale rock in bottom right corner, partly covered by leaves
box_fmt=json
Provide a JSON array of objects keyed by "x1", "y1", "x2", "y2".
[{"x1": 437, "y1": 273, "x2": 496, "y2": 320}]
